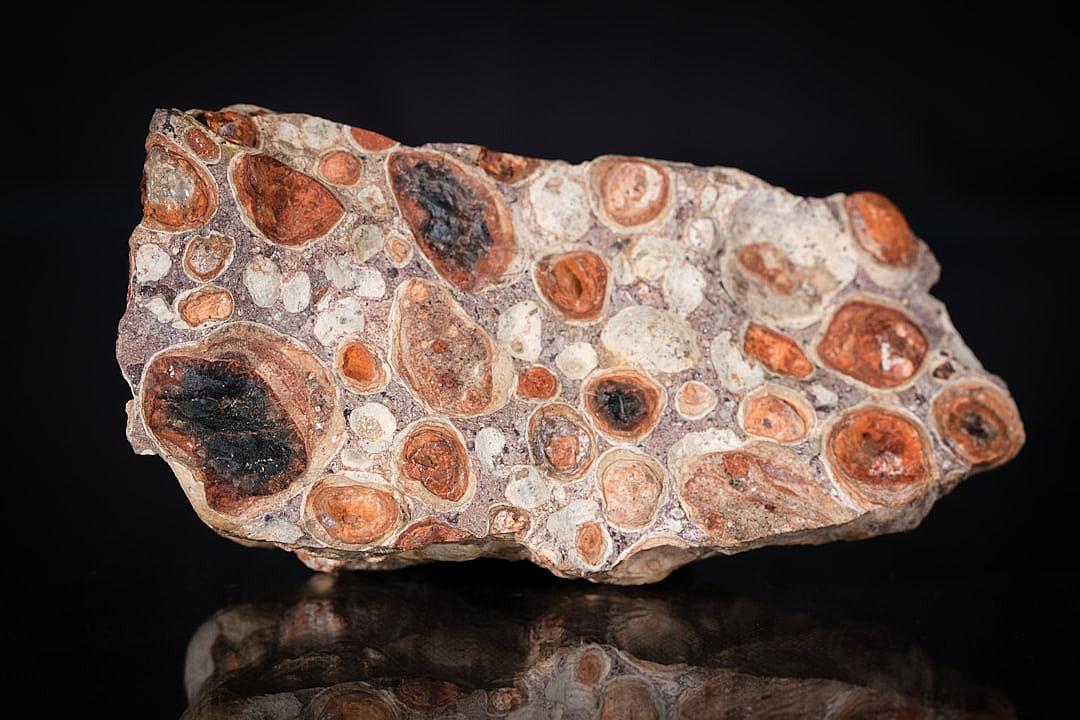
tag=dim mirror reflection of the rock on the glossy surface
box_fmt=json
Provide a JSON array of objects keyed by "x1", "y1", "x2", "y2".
[{"x1": 184, "y1": 573, "x2": 1015, "y2": 720}]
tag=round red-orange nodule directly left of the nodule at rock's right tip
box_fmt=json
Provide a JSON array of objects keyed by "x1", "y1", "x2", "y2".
[{"x1": 825, "y1": 406, "x2": 933, "y2": 506}]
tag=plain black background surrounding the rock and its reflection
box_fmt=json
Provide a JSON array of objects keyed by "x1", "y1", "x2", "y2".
[{"x1": 10, "y1": 3, "x2": 1080, "y2": 718}]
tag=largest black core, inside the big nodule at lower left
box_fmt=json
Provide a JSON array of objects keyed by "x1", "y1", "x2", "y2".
[{"x1": 162, "y1": 361, "x2": 302, "y2": 495}]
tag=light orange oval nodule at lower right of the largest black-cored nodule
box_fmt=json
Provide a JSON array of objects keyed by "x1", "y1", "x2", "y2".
[{"x1": 307, "y1": 483, "x2": 401, "y2": 545}]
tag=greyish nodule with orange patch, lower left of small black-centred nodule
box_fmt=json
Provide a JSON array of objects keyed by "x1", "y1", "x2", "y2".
[{"x1": 528, "y1": 403, "x2": 596, "y2": 483}]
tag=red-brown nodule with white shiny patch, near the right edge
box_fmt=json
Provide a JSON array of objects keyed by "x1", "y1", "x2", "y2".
[{"x1": 818, "y1": 300, "x2": 928, "y2": 388}]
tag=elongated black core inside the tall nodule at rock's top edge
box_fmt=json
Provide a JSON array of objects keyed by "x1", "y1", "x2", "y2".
[{"x1": 401, "y1": 160, "x2": 494, "y2": 269}]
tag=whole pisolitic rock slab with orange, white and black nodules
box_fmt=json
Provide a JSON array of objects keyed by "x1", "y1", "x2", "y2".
[{"x1": 117, "y1": 106, "x2": 1024, "y2": 584}]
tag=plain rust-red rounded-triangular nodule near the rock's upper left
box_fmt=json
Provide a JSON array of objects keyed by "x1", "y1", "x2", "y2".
[{"x1": 232, "y1": 153, "x2": 345, "y2": 247}]
